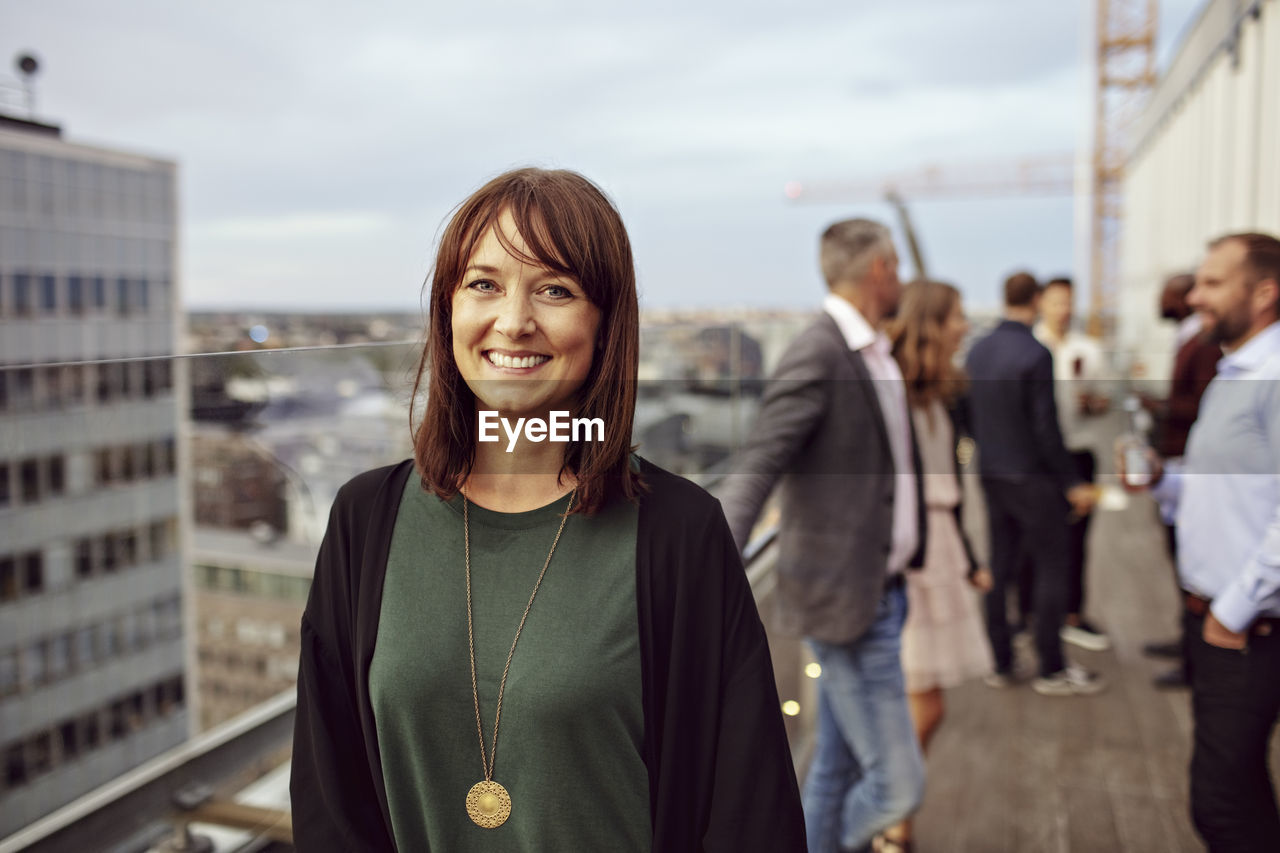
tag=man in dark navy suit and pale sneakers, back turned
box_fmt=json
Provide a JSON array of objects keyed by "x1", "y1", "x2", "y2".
[{"x1": 966, "y1": 273, "x2": 1103, "y2": 695}]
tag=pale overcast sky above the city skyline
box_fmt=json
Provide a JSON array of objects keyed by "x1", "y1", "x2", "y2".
[{"x1": 0, "y1": 0, "x2": 1202, "y2": 310}]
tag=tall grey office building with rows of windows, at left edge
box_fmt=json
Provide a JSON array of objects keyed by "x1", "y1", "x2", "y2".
[{"x1": 0, "y1": 117, "x2": 191, "y2": 838}]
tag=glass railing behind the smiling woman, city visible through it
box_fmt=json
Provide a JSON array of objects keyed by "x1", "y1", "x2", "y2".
[{"x1": 0, "y1": 315, "x2": 804, "y2": 849}]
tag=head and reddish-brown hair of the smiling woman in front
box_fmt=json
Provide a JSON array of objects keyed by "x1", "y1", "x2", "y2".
[{"x1": 415, "y1": 169, "x2": 640, "y2": 514}]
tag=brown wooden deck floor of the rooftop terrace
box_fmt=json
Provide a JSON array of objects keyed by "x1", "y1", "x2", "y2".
[{"x1": 915, "y1": 484, "x2": 1280, "y2": 853}]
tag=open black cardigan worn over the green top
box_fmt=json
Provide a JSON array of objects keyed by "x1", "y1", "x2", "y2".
[{"x1": 289, "y1": 460, "x2": 805, "y2": 853}]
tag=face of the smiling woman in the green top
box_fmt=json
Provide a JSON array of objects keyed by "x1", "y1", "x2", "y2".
[{"x1": 453, "y1": 211, "x2": 600, "y2": 418}]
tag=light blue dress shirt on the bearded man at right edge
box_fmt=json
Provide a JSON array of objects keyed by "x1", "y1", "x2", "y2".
[{"x1": 1152, "y1": 323, "x2": 1280, "y2": 631}]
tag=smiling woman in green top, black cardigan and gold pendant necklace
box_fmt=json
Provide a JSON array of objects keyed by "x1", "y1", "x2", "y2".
[{"x1": 291, "y1": 169, "x2": 804, "y2": 853}]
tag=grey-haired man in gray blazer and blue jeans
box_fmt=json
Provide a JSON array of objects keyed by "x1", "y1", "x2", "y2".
[{"x1": 721, "y1": 219, "x2": 925, "y2": 853}]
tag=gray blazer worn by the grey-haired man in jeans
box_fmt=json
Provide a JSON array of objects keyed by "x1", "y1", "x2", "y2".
[{"x1": 721, "y1": 313, "x2": 925, "y2": 643}]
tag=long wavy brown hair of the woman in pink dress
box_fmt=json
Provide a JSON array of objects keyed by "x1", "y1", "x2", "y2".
[{"x1": 890, "y1": 280, "x2": 968, "y2": 409}]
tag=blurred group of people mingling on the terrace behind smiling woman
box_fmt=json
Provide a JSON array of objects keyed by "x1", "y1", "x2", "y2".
[{"x1": 722, "y1": 219, "x2": 1280, "y2": 853}]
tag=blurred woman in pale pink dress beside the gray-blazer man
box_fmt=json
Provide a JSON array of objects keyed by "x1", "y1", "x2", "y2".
[{"x1": 876, "y1": 282, "x2": 992, "y2": 853}]
